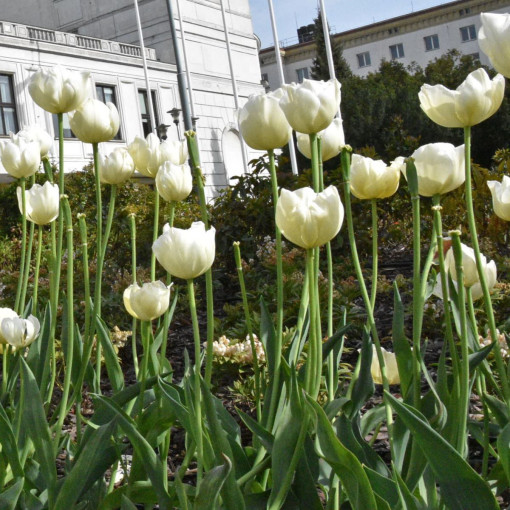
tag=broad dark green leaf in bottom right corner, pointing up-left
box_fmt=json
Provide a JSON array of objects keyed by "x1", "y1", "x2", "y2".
[{"x1": 385, "y1": 392, "x2": 499, "y2": 510}]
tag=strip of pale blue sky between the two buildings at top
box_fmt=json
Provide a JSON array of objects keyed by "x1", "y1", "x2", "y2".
[{"x1": 250, "y1": 0, "x2": 449, "y2": 48}]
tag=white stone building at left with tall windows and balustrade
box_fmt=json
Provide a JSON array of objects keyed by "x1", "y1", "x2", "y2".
[{"x1": 0, "y1": 0, "x2": 261, "y2": 196}]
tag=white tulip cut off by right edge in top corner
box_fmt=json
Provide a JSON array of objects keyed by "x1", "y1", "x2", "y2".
[{"x1": 478, "y1": 12, "x2": 510, "y2": 78}]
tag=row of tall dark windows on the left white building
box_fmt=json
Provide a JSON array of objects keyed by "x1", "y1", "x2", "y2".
[{"x1": 0, "y1": 74, "x2": 159, "y2": 140}]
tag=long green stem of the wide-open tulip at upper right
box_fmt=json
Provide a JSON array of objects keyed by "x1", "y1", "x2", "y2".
[{"x1": 464, "y1": 126, "x2": 510, "y2": 407}]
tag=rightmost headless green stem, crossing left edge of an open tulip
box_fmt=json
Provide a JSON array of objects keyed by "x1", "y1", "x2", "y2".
[{"x1": 450, "y1": 230, "x2": 469, "y2": 457}]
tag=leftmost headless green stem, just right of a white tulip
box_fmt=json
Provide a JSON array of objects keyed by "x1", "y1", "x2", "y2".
[{"x1": 53, "y1": 195, "x2": 74, "y2": 455}]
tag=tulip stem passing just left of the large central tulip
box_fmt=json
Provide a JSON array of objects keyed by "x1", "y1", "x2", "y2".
[{"x1": 266, "y1": 149, "x2": 283, "y2": 430}]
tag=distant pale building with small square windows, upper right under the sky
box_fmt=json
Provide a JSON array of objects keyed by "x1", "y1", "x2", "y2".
[{"x1": 260, "y1": 0, "x2": 510, "y2": 90}]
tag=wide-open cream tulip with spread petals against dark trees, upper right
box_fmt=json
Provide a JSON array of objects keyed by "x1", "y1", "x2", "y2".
[{"x1": 418, "y1": 69, "x2": 505, "y2": 128}]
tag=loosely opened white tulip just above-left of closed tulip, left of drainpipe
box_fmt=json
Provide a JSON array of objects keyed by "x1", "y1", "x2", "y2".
[{"x1": 128, "y1": 133, "x2": 176, "y2": 177}]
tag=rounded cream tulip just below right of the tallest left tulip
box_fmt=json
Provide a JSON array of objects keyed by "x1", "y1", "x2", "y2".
[{"x1": 69, "y1": 97, "x2": 120, "y2": 143}]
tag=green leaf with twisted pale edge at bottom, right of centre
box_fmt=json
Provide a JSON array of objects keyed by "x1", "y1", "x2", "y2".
[{"x1": 308, "y1": 398, "x2": 377, "y2": 510}]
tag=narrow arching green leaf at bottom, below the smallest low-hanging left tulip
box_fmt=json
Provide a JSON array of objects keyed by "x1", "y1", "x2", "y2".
[{"x1": 96, "y1": 396, "x2": 171, "y2": 510}]
